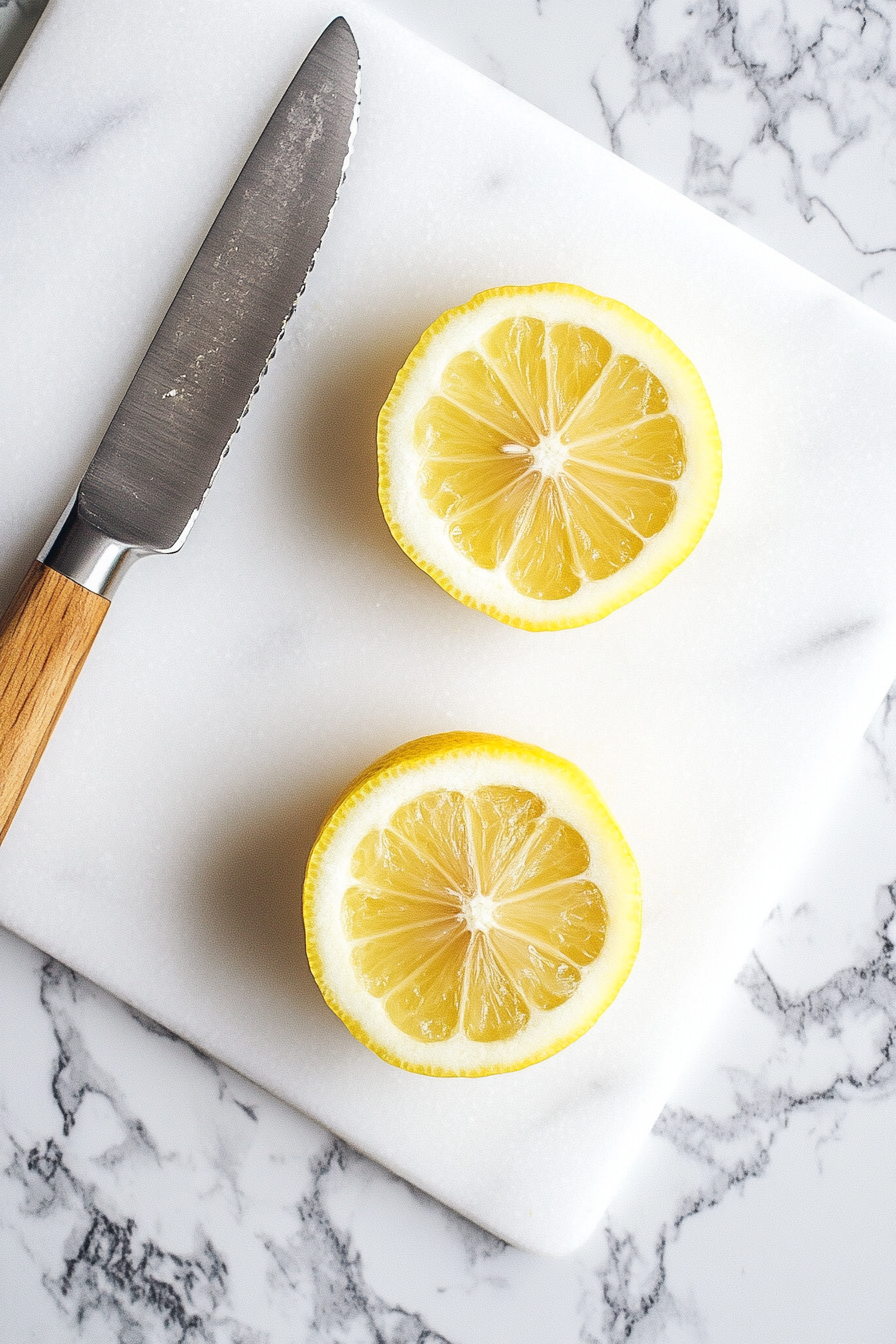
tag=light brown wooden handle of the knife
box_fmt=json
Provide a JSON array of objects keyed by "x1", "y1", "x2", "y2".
[{"x1": 0, "y1": 562, "x2": 109, "y2": 840}]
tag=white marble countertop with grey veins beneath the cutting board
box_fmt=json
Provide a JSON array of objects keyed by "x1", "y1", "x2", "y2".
[{"x1": 0, "y1": 0, "x2": 896, "y2": 1344}]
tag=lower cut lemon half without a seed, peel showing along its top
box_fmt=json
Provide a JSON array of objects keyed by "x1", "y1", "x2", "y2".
[{"x1": 304, "y1": 732, "x2": 641, "y2": 1077}]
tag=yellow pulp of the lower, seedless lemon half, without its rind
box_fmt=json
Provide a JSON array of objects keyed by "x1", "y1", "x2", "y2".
[{"x1": 343, "y1": 785, "x2": 607, "y2": 1042}]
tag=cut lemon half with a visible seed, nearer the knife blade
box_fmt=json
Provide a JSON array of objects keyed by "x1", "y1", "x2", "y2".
[{"x1": 377, "y1": 285, "x2": 721, "y2": 630}]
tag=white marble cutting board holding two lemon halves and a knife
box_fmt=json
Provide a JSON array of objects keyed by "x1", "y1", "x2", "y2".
[{"x1": 0, "y1": 0, "x2": 896, "y2": 1253}]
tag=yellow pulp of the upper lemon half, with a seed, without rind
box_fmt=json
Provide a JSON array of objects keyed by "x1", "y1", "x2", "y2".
[{"x1": 415, "y1": 317, "x2": 685, "y2": 599}]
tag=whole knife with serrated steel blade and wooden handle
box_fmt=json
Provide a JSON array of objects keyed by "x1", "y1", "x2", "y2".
[{"x1": 0, "y1": 19, "x2": 360, "y2": 840}]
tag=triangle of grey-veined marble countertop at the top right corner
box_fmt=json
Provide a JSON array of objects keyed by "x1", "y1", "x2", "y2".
[{"x1": 379, "y1": 0, "x2": 896, "y2": 317}]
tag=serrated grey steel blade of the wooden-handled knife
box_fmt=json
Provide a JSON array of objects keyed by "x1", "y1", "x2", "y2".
[{"x1": 46, "y1": 19, "x2": 359, "y2": 591}]
